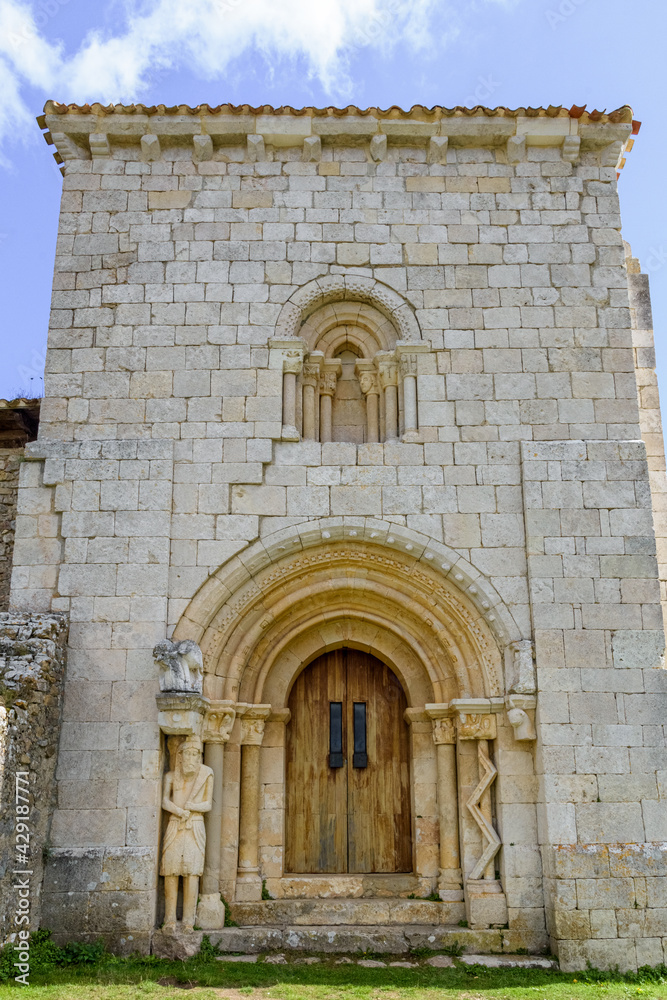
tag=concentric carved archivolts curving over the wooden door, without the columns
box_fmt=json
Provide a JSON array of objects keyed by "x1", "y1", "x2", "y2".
[{"x1": 176, "y1": 520, "x2": 511, "y2": 708}]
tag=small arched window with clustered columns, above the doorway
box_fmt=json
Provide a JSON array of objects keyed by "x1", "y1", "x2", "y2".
[{"x1": 271, "y1": 275, "x2": 429, "y2": 444}]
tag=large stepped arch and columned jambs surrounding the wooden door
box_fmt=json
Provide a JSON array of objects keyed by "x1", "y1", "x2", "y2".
[{"x1": 174, "y1": 517, "x2": 530, "y2": 923}]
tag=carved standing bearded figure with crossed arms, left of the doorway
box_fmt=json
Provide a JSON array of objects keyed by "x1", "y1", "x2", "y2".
[{"x1": 160, "y1": 736, "x2": 213, "y2": 932}]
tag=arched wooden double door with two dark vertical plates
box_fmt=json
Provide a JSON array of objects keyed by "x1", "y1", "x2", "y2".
[{"x1": 285, "y1": 648, "x2": 412, "y2": 873}]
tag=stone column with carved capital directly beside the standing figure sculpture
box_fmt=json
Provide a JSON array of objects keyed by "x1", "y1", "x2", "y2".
[{"x1": 197, "y1": 701, "x2": 236, "y2": 930}]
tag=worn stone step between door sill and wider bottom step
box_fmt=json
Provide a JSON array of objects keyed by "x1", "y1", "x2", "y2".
[{"x1": 230, "y1": 897, "x2": 465, "y2": 927}]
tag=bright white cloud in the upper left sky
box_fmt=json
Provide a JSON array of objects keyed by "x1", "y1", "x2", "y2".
[{"x1": 0, "y1": 0, "x2": 514, "y2": 156}]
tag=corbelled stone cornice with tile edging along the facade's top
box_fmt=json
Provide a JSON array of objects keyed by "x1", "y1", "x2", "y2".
[{"x1": 37, "y1": 101, "x2": 639, "y2": 175}]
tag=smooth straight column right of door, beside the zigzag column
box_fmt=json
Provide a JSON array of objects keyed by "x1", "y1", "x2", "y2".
[{"x1": 426, "y1": 705, "x2": 463, "y2": 902}]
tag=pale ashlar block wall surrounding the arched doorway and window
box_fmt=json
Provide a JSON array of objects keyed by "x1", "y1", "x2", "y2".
[{"x1": 7, "y1": 104, "x2": 667, "y2": 968}]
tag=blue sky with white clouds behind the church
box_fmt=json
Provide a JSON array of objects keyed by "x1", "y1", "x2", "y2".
[{"x1": 0, "y1": 0, "x2": 667, "y2": 414}]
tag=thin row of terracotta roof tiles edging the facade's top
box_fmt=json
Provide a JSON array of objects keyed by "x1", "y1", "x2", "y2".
[{"x1": 44, "y1": 100, "x2": 633, "y2": 124}]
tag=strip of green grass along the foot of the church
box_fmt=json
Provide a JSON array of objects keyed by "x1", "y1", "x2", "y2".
[{"x1": 0, "y1": 955, "x2": 667, "y2": 1000}]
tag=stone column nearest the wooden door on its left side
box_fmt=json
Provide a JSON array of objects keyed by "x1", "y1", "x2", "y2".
[{"x1": 236, "y1": 705, "x2": 271, "y2": 902}]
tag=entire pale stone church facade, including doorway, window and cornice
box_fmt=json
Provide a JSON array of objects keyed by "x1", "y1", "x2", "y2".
[{"x1": 2, "y1": 103, "x2": 667, "y2": 969}]
